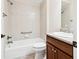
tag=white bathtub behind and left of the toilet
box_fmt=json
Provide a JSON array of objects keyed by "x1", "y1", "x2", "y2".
[{"x1": 5, "y1": 38, "x2": 44, "y2": 59}]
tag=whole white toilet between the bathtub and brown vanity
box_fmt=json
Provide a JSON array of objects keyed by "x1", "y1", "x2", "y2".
[{"x1": 34, "y1": 42, "x2": 46, "y2": 59}]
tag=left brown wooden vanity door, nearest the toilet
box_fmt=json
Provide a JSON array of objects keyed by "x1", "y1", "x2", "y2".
[{"x1": 47, "y1": 43, "x2": 55, "y2": 59}]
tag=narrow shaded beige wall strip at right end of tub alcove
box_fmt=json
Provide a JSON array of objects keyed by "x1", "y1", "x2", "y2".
[{"x1": 40, "y1": 0, "x2": 47, "y2": 39}]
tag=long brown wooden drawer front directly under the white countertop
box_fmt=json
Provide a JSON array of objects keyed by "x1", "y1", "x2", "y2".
[{"x1": 47, "y1": 36, "x2": 73, "y2": 56}]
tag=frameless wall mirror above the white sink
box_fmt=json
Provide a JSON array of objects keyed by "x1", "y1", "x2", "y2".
[{"x1": 61, "y1": 0, "x2": 73, "y2": 32}]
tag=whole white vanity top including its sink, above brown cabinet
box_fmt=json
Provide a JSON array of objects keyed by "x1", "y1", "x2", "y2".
[{"x1": 47, "y1": 32, "x2": 73, "y2": 44}]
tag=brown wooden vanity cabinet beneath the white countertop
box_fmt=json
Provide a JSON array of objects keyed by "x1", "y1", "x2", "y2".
[{"x1": 46, "y1": 35, "x2": 73, "y2": 59}]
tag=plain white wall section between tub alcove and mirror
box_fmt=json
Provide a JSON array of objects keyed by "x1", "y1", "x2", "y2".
[{"x1": 47, "y1": 0, "x2": 61, "y2": 32}]
